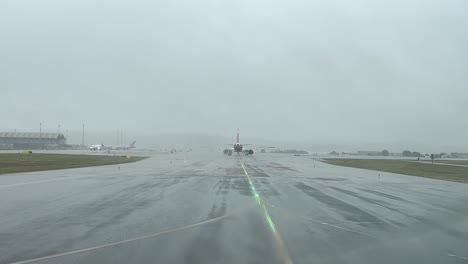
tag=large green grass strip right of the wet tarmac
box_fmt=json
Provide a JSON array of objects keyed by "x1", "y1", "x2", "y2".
[{"x1": 324, "y1": 159, "x2": 468, "y2": 183}]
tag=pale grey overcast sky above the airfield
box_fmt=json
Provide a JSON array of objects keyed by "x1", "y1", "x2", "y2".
[{"x1": 0, "y1": 0, "x2": 468, "y2": 152}]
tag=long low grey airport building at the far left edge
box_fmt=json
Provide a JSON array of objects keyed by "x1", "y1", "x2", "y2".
[{"x1": 0, "y1": 132, "x2": 67, "y2": 149}]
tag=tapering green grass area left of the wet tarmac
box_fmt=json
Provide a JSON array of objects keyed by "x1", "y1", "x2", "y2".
[{"x1": 0, "y1": 153, "x2": 146, "y2": 174}]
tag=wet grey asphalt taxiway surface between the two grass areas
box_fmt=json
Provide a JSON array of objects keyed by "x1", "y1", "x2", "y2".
[{"x1": 0, "y1": 151, "x2": 468, "y2": 263}]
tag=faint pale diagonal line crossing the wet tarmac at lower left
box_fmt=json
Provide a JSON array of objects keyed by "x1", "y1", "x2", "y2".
[{"x1": 9, "y1": 208, "x2": 249, "y2": 264}]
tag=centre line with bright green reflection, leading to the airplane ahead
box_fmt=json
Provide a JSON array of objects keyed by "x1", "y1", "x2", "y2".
[{"x1": 239, "y1": 158, "x2": 293, "y2": 264}]
